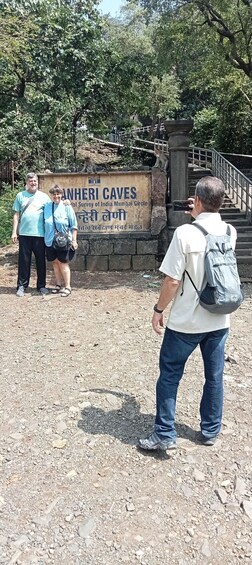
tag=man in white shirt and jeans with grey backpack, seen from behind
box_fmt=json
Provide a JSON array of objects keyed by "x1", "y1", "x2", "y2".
[{"x1": 138, "y1": 176, "x2": 243, "y2": 450}]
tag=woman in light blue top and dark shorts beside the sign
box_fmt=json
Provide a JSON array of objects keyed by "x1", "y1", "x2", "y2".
[{"x1": 44, "y1": 184, "x2": 78, "y2": 297}]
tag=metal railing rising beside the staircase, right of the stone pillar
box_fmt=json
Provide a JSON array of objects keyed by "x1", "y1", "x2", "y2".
[{"x1": 188, "y1": 147, "x2": 252, "y2": 224}]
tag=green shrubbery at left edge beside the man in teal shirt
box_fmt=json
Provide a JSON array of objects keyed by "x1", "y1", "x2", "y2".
[{"x1": 0, "y1": 185, "x2": 20, "y2": 245}]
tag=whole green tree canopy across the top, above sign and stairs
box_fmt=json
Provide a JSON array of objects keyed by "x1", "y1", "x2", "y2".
[{"x1": 0, "y1": 0, "x2": 252, "y2": 175}]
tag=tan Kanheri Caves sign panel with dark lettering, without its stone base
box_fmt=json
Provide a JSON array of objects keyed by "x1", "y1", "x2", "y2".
[{"x1": 39, "y1": 172, "x2": 151, "y2": 235}]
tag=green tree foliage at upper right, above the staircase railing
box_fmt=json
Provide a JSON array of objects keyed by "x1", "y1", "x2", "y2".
[{"x1": 140, "y1": 0, "x2": 252, "y2": 153}]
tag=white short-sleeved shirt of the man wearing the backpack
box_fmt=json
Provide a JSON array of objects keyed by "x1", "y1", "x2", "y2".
[{"x1": 160, "y1": 212, "x2": 237, "y2": 333}]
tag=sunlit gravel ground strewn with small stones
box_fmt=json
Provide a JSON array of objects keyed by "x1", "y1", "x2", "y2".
[{"x1": 0, "y1": 248, "x2": 252, "y2": 565}]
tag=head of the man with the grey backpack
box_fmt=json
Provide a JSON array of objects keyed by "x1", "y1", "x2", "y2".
[{"x1": 195, "y1": 176, "x2": 225, "y2": 212}]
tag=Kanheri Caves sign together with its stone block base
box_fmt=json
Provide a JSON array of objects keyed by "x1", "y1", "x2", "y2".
[{"x1": 38, "y1": 168, "x2": 167, "y2": 271}]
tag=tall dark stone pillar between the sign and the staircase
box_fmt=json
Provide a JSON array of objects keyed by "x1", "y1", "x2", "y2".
[{"x1": 164, "y1": 120, "x2": 193, "y2": 241}]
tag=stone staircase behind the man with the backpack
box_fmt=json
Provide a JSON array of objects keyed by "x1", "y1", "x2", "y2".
[{"x1": 188, "y1": 167, "x2": 252, "y2": 270}]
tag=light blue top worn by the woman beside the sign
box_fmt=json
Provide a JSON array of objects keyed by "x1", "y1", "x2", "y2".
[{"x1": 44, "y1": 201, "x2": 78, "y2": 247}]
